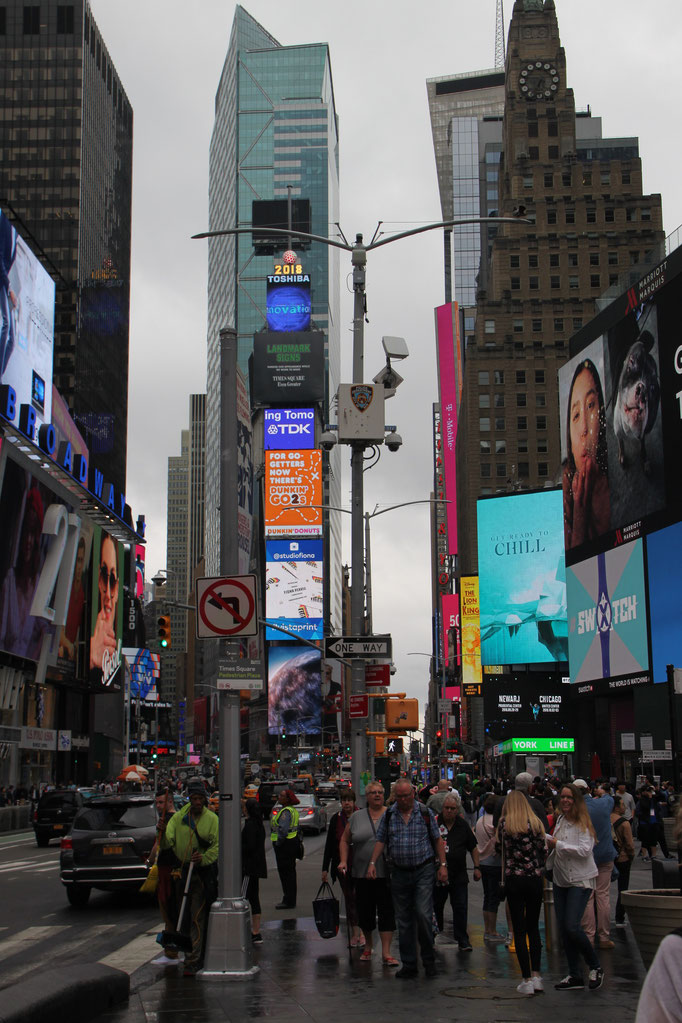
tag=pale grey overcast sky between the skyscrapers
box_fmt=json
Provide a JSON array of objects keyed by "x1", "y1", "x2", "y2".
[{"x1": 91, "y1": 0, "x2": 682, "y2": 712}]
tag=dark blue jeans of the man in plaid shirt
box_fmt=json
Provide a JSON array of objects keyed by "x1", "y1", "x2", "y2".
[{"x1": 391, "y1": 860, "x2": 436, "y2": 970}]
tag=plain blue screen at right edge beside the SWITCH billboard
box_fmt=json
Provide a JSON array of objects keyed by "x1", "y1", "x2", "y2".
[{"x1": 646, "y1": 522, "x2": 682, "y2": 682}]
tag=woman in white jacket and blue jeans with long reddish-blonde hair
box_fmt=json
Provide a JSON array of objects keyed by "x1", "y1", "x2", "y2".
[{"x1": 546, "y1": 785, "x2": 604, "y2": 991}]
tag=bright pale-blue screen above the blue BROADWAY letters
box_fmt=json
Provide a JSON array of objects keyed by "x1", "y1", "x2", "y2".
[{"x1": 0, "y1": 211, "x2": 54, "y2": 424}]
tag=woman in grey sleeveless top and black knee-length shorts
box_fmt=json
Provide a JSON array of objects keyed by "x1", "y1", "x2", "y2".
[{"x1": 338, "y1": 782, "x2": 400, "y2": 967}]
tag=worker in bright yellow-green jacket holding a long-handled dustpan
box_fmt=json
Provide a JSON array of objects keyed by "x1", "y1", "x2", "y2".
[{"x1": 166, "y1": 777, "x2": 218, "y2": 977}]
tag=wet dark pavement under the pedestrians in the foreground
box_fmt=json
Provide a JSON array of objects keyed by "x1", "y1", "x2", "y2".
[{"x1": 90, "y1": 836, "x2": 650, "y2": 1023}]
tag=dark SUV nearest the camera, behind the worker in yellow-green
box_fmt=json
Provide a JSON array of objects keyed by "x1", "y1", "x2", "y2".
[{"x1": 59, "y1": 793, "x2": 156, "y2": 907}]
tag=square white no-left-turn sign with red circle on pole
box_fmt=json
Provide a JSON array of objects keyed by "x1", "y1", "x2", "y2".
[{"x1": 196, "y1": 575, "x2": 258, "y2": 639}]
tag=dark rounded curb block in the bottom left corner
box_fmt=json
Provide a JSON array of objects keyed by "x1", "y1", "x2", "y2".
[{"x1": 0, "y1": 963, "x2": 130, "y2": 1023}]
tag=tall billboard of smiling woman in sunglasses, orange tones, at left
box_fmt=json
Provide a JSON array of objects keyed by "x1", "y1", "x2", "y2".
[{"x1": 90, "y1": 528, "x2": 123, "y2": 688}]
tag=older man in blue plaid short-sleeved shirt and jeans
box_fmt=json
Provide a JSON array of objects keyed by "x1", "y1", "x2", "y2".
[{"x1": 367, "y1": 779, "x2": 448, "y2": 979}]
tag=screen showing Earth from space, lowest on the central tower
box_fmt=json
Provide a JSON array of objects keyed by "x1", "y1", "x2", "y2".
[{"x1": 268, "y1": 643, "x2": 322, "y2": 736}]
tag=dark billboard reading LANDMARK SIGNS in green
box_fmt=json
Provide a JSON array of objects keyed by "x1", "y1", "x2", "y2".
[{"x1": 253, "y1": 330, "x2": 325, "y2": 405}]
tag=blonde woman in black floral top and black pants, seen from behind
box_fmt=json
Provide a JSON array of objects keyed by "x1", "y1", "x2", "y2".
[{"x1": 497, "y1": 790, "x2": 546, "y2": 994}]
